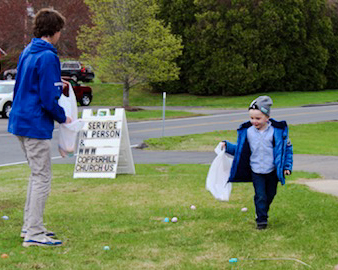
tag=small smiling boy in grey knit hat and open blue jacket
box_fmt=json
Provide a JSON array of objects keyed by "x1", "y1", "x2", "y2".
[{"x1": 223, "y1": 96, "x2": 293, "y2": 230}]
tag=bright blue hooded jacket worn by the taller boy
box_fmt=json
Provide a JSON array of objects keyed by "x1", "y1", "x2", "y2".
[{"x1": 8, "y1": 38, "x2": 66, "y2": 139}]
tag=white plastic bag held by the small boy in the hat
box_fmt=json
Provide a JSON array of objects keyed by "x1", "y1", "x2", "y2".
[{"x1": 206, "y1": 143, "x2": 232, "y2": 201}]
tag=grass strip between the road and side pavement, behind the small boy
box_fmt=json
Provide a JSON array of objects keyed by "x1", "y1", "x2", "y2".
[{"x1": 145, "y1": 122, "x2": 338, "y2": 156}]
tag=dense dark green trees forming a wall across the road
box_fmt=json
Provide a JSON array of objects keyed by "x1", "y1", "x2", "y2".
[{"x1": 158, "y1": 0, "x2": 338, "y2": 95}]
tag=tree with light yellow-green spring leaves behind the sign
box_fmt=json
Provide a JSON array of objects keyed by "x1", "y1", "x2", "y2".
[{"x1": 78, "y1": 0, "x2": 182, "y2": 107}]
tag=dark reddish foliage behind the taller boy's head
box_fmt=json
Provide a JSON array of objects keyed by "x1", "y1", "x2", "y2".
[{"x1": 0, "y1": 0, "x2": 90, "y2": 58}]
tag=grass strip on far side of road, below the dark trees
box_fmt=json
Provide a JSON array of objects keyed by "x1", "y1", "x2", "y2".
[{"x1": 88, "y1": 83, "x2": 338, "y2": 108}]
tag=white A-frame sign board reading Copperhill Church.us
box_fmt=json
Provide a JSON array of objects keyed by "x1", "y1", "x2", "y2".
[{"x1": 74, "y1": 109, "x2": 135, "y2": 178}]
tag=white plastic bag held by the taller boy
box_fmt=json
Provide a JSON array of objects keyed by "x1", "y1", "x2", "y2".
[{"x1": 59, "y1": 83, "x2": 84, "y2": 157}]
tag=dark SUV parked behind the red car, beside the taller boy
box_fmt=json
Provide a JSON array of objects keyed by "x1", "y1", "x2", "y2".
[{"x1": 61, "y1": 61, "x2": 95, "y2": 82}]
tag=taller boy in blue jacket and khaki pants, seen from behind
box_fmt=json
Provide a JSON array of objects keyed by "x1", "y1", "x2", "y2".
[{"x1": 8, "y1": 9, "x2": 71, "y2": 247}]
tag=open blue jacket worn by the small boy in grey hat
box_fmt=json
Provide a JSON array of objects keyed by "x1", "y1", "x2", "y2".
[{"x1": 226, "y1": 119, "x2": 293, "y2": 185}]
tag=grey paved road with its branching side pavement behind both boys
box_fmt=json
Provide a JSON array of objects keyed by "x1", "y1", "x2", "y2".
[{"x1": 0, "y1": 105, "x2": 338, "y2": 196}]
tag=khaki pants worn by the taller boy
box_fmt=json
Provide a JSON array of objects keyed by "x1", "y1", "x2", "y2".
[{"x1": 18, "y1": 136, "x2": 52, "y2": 239}]
